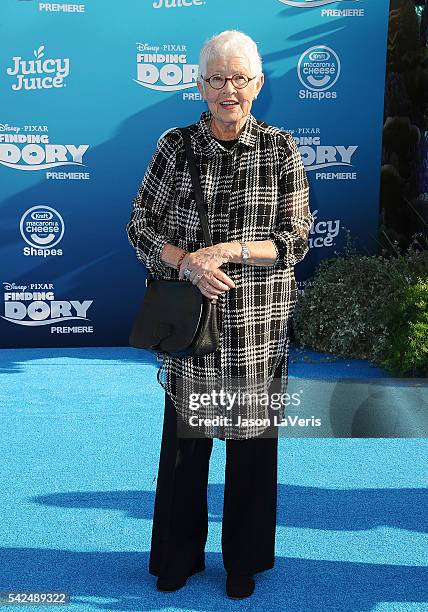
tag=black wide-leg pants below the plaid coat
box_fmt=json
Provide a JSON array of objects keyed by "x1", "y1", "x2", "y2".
[{"x1": 149, "y1": 366, "x2": 278, "y2": 576}]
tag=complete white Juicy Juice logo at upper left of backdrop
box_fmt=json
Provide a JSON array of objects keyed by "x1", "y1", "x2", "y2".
[{"x1": 6, "y1": 45, "x2": 70, "y2": 91}]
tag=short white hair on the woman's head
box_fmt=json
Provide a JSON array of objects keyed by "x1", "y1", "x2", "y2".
[{"x1": 198, "y1": 30, "x2": 262, "y2": 84}]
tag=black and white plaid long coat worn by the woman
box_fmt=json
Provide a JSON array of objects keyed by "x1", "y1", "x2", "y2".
[{"x1": 126, "y1": 111, "x2": 314, "y2": 439}]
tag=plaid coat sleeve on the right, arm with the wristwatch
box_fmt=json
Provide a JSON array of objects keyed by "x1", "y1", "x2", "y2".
[{"x1": 269, "y1": 133, "x2": 314, "y2": 269}]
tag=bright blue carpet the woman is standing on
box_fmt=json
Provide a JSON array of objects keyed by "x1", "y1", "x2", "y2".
[{"x1": 0, "y1": 348, "x2": 428, "y2": 612}]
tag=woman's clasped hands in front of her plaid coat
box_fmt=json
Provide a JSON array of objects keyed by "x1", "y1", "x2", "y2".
[{"x1": 178, "y1": 243, "x2": 235, "y2": 301}]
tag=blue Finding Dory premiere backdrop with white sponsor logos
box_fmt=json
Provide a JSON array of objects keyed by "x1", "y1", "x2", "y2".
[{"x1": 0, "y1": 0, "x2": 389, "y2": 347}]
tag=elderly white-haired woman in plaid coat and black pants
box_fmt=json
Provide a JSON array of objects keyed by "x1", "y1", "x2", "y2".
[{"x1": 127, "y1": 31, "x2": 313, "y2": 598}]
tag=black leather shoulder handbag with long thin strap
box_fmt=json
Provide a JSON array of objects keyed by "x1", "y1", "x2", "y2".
[{"x1": 129, "y1": 128, "x2": 220, "y2": 357}]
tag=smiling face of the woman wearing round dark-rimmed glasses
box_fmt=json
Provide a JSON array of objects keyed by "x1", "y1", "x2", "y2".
[{"x1": 198, "y1": 55, "x2": 264, "y2": 128}]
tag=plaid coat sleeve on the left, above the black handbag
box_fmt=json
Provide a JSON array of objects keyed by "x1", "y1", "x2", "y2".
[{"x1": 126, "y1": 132, "x2": 177, "y2": 276}]
